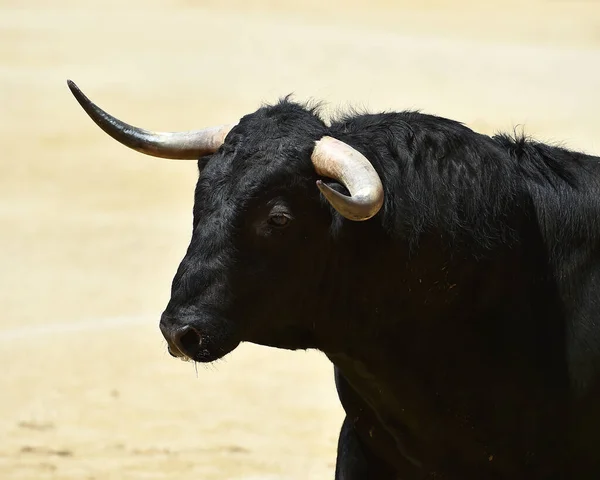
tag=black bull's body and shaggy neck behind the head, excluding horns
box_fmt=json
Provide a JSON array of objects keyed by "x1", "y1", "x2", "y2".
[{"x1": 326, "y1": 114, "x2": 600, "y2": 480}]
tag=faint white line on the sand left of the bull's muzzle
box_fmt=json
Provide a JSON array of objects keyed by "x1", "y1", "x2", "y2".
[{"x1": 0, "y1": 313, "x2": 160, "y2": 343}]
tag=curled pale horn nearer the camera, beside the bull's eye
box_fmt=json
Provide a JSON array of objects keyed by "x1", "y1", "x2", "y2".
[{"x1": 311, "y1": 136, "x2": 383, "y2": 221}]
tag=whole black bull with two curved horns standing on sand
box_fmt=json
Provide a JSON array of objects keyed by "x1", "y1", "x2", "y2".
[{"x1": 69, "y1": 83, "x2": 600, "y2": 480}]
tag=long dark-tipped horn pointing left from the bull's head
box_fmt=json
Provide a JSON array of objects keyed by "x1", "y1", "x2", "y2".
[{"x1": 67, "y1": 80, "x2": 234, "y2": 160}]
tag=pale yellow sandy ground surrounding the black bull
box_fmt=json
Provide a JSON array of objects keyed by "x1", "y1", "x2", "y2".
[{"x1": 0, "y1": 0, "x2": 600, "y2": 480}]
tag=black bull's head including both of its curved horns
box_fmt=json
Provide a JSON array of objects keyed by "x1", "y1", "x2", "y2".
[{"x1": 68, "y1": 81, "x2": 383, "y2": 362}]
